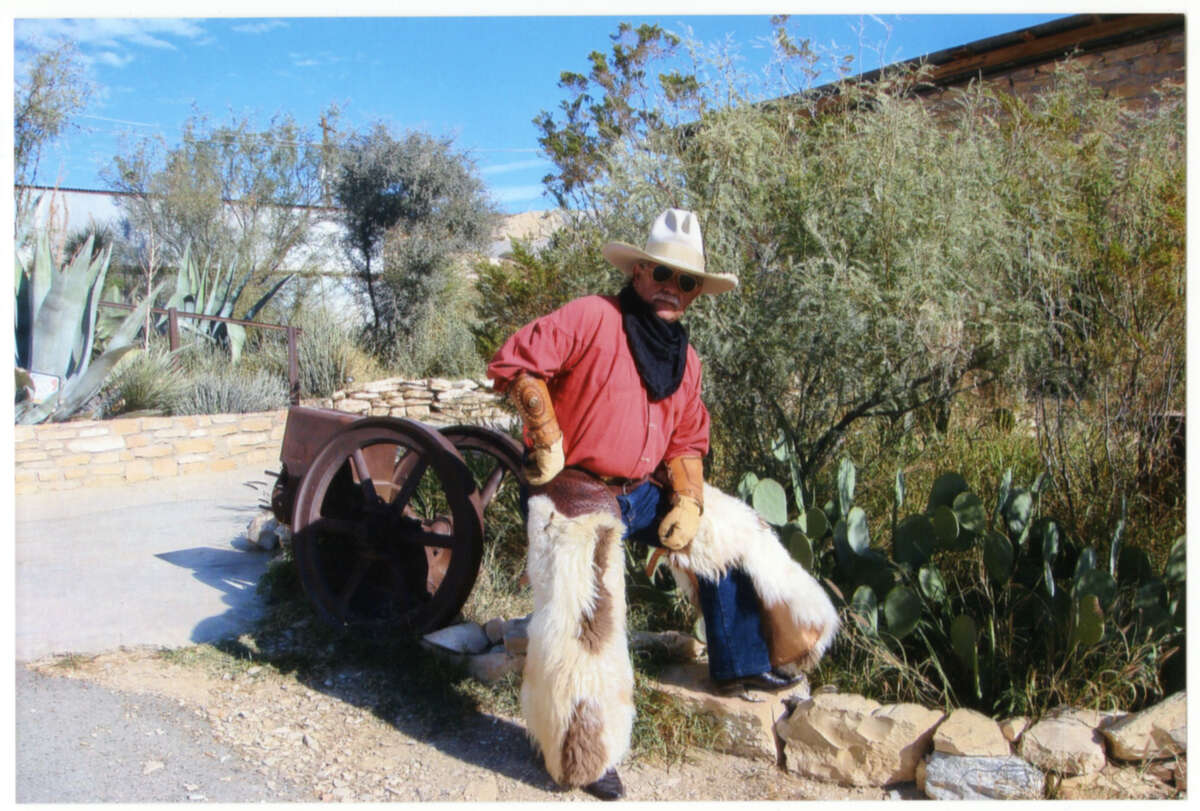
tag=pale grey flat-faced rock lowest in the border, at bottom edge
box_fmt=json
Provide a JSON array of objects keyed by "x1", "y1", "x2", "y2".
[{"x1": 917, "y1": 751, "x2": 1045, "y2": 800}]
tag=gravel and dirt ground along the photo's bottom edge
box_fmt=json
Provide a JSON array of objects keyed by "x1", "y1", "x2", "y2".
[{"x1": 17, "y1": 649, "x2": 887, "y2": 803}]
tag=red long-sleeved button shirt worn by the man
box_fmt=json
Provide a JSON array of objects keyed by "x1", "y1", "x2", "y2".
[{"x1": 487, "y1": 295, "x2": 709, "y2": 479}]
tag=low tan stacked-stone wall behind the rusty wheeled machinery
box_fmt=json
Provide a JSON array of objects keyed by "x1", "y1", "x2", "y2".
[{"x1": 13, "y1": 378, "x2": 512, "y2": 494}]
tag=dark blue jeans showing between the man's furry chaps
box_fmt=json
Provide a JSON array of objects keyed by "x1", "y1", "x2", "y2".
[{"x1": 617, "y1": 482, "x2": 770, "y2": 680}]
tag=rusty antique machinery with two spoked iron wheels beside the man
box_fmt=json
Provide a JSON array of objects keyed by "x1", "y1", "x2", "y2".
[{"x1": 271, "y1": 406, "x2": 522, "y2": 633}]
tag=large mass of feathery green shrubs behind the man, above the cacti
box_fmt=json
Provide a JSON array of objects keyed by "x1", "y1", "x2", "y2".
[{"x1": 532, "y1": 20, "x2": 1186, "y2": 528}]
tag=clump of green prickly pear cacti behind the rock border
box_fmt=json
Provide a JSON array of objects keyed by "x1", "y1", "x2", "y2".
[{"x1": 739, "y1": 453, "x2": 1186, "y2": 714}]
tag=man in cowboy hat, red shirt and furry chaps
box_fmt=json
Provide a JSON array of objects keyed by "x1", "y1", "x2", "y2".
[{"x1": 487, "y1": 209, "x2": 836, "y2": 799}]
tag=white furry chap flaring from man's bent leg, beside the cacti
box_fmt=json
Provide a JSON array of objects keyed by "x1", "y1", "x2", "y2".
[{"x1": 667, "y1": 485, "x2": 838, "y2": 673}]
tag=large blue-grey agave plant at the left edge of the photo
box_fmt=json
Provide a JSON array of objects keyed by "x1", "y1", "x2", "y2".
[{"x1": 14, "y1": 232, "x2": 157, "y2": 425}]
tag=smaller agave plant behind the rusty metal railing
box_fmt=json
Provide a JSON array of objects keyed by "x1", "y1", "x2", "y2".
[{"x1": 160, "y1": 246, "x2": 292, "y2": 364}]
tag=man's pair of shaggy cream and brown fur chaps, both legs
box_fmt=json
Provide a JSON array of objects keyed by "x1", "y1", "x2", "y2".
[{"x1": 521, "y1": 470, "x2": 838, "y2": 786}]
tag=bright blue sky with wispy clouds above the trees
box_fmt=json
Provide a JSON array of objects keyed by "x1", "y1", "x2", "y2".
[{"x1": 13, "y1": 2, "x2": 1066, "y2": 212}]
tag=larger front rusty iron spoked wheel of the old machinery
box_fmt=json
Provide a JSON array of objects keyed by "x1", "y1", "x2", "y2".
[{"x1": 293, "y1": 417, "x2": 484, "y2": 635}]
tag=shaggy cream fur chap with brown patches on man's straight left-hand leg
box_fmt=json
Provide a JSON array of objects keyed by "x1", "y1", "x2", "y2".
[{"x1": 521, "y1": 487, "x2": 634, "y2": 786}]
